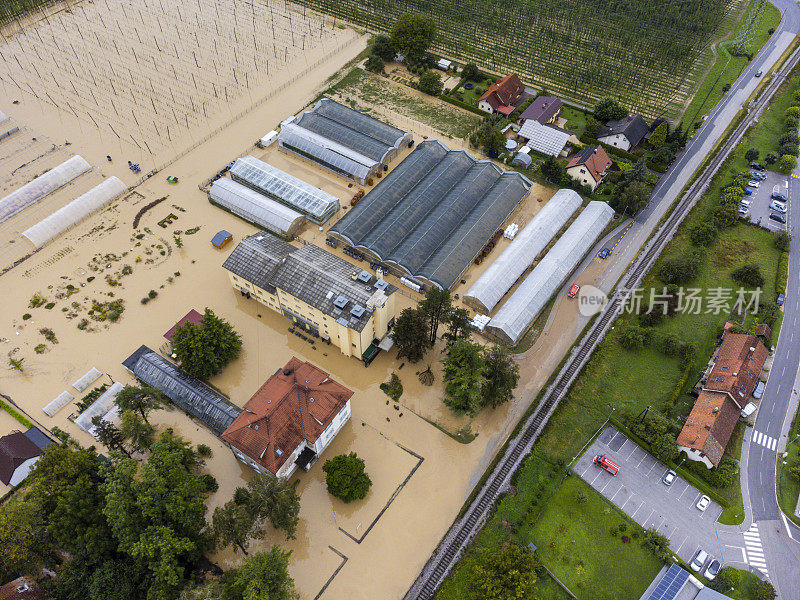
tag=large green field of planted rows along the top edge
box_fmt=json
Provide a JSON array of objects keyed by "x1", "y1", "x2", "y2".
[{"x1": 290, "y1": 0, "x2": 741, "y2": 118}]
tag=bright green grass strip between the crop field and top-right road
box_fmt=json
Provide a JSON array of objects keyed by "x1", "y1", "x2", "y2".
[{"x1": 683, "y1": 0, "x2": 781, "y2": 126}]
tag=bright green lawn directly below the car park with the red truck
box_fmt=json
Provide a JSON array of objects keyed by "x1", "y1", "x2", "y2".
[{"x1": 520, "y1": 477, "x2": 663, "y2": 600}]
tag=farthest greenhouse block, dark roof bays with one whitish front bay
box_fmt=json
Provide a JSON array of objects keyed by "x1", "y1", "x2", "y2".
[{"x1": 278, "y1": 98, "x2": 413, "y2": 185}]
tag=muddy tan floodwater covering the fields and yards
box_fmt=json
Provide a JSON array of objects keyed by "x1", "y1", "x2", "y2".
[{"x1": 0, "y1": 0, "x2": 592, "y2": 600}]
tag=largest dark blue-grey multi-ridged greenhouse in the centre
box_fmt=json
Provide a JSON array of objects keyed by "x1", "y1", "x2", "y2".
[{"x1": 328, "y1": 140, "x2": 531, "y2": 289}]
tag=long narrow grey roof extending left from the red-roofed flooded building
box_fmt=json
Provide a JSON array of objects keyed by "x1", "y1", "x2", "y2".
[{"x1": 122, "y1": 346, "x2": 242, "y2": 435}]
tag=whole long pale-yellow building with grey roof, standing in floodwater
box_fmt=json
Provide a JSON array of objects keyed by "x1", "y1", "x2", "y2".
[{"x1": 222, "y1": 233, "x2": 397, "y2": 364}]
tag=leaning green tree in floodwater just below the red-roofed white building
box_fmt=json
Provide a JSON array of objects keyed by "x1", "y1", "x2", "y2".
[{"x1": 234, "y1": 473, "x2": 300, "y2": 539}]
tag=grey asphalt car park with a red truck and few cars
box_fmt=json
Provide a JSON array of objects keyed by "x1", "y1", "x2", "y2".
[{"x1": 574, "y1": 427, "x2": 722, "y2": 562}]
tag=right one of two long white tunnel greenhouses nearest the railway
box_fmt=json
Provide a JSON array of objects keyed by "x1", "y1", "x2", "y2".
[{"x1": 486, "y1": 201, "x2": 614, "y2": 345}]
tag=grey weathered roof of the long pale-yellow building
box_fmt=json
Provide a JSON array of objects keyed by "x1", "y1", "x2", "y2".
[{"x1": 223, "y1": 233, "x2": 397, "y2": 331}]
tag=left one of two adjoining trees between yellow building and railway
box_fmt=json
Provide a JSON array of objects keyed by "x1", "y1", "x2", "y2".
[{"x1": 443, "y1": 340, "x2": 484, "y2": 415}]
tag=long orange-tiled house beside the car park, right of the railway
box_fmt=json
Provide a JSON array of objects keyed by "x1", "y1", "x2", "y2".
[{"x1": 678, "y1": 333, "x2": 769, "y2": 468}]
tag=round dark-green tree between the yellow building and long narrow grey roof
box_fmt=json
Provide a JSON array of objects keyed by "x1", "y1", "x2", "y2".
[{"x1": 172, "y1": 308, "x2": 242, "y2": 379}]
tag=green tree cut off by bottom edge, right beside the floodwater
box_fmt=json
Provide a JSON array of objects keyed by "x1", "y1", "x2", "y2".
[{"x1": 222, "y1": 546, "x2": 295, "y2": 600}]
